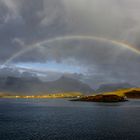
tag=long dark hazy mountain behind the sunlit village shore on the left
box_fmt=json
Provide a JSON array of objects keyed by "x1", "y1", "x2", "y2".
[{"x1": 0, "y1": 76, "x2": 93, "y2": 95}]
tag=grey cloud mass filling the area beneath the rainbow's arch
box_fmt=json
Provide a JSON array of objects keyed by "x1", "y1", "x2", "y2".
[{"x1": 5, "y1": 40, "x2": 140, "y2": 85}]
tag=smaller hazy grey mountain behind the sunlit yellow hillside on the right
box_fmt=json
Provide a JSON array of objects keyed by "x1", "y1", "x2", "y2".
[{"x1": 96, "y1": 83, "x2": 136, "y2": 92}]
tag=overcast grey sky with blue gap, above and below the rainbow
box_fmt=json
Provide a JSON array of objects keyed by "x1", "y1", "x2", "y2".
[{"x1": 0, "y1": 0, "x2": 140, "y2": 85}]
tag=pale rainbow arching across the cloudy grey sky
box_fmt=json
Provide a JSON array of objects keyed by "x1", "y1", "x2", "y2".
[{"x1": 3, "y1": 35, "x2": 140, "y2": 66}]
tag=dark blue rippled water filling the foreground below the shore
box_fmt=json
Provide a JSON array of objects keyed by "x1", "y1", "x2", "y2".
[{"x1": 0, "y1": 99, "x2": 140, "y2": 140}]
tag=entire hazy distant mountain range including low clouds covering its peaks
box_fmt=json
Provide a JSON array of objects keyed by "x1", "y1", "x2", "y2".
[{"x1": 0, "y1": 67, "x2": 136, "y2": 95}]
